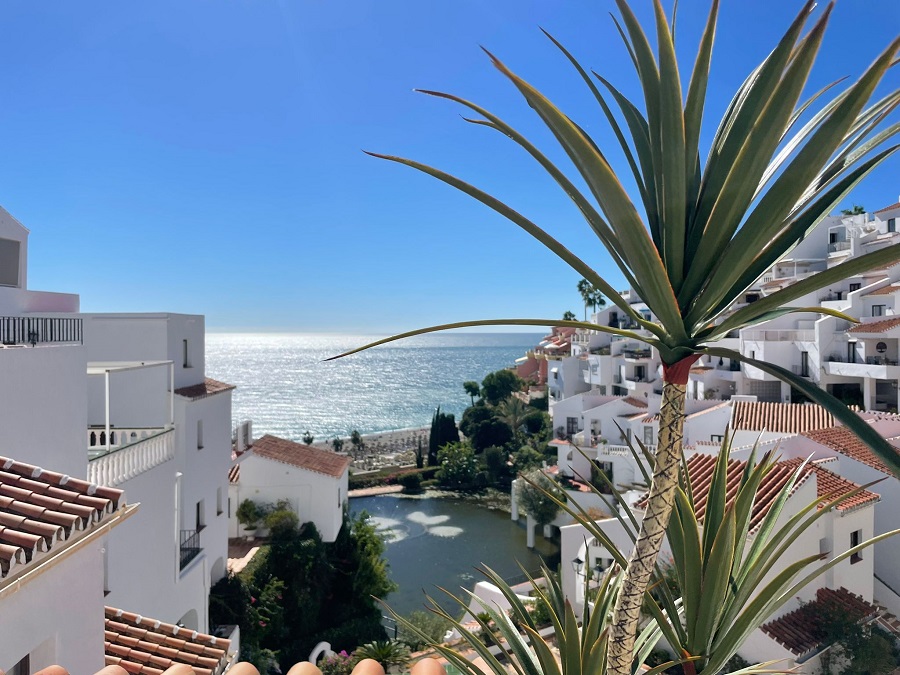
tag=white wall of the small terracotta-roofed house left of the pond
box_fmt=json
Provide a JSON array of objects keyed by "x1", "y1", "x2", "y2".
[{"x1": 230, "y1": 454, "x2": 348, "y2": 542}]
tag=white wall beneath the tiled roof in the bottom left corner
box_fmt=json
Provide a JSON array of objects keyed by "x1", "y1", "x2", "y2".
[{"x1": 0, "y1": 544, "x2": 107, "y2": 673}]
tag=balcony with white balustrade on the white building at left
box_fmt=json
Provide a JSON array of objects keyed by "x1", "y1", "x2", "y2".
[{"x1": 88, "y1": 429, "x2": 175, "y2": 487}]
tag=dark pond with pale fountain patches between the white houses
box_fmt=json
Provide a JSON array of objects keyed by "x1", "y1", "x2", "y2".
[{"x1": 350, "y1": 494, "x2": 557, "y2": 615}]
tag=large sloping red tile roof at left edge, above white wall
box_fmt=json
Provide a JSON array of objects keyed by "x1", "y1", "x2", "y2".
[{"x1": 0, "y1": 457, "x2": 125, "y2": 584}]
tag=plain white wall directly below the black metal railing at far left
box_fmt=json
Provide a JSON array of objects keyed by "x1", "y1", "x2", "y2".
[{"x1": 0, "y1": 345, "x2": 87, "y2": 478}]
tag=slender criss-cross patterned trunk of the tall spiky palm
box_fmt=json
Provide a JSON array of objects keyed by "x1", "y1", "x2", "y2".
[{"x1": 606, "y1": 356, "x2": 698, "y2": 675}]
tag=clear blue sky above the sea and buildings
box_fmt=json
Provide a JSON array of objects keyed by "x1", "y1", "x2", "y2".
[{"x1": 0, "y1": 0, "x2": 900, "y2": 332}]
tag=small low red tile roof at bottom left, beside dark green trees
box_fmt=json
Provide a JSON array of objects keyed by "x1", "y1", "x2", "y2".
[{"x1": 104, "y1": 607, "x2": 232, "y2": 675}]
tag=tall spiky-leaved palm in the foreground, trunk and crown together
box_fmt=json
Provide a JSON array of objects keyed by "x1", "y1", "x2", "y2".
[{"x1": 340, "y1": 0, "x2": 900, "y2": 675}]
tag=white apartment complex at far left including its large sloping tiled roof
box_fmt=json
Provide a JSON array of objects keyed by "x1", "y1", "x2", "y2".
[{"x1": 0, "y1": 209, "x2": 233, "y2": 673}]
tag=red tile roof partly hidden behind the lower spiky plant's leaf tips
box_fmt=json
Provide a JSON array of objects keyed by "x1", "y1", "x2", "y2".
[{"x1": 635, "y1": 454, "x2": 880, "y2": 533}]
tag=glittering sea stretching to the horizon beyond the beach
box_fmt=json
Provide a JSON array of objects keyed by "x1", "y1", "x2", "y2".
[{"x1": 206, "y1": 332, "x2": 542, "y2": 441}]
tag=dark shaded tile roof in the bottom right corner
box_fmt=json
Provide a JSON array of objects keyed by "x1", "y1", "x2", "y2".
[{"x1": 762, "y1": 587, "x2": 877, "y2": 656}]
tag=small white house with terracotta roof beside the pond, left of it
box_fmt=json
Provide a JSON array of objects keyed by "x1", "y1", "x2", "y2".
[{"x1": 229, "y1": 435, "x2": 351, "y2": 543}]
